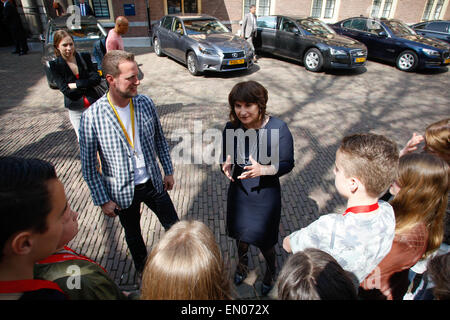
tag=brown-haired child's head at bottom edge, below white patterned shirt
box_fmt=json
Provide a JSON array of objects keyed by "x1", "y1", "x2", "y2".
[{"x1": 277, "y1": 248, "x2": 357, "y2": 300}]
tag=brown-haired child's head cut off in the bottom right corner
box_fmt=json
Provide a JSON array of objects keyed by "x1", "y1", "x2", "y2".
[{"x1": 427, "y1": 252, "x2": 450, "y2": 300}]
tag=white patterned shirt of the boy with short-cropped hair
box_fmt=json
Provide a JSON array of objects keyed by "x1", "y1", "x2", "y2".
[{"x1": 289, "y1": 200, "x2": 395, "y2": 283}]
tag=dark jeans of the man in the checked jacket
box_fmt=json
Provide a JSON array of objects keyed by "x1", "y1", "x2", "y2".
[{"x1": 119, "y1": 179, "x2": 179, "y2": 272}]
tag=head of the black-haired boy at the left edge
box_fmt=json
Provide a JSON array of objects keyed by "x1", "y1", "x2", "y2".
[{"x1": 0, "y1": 157, "x2": 70, "y2": 262}]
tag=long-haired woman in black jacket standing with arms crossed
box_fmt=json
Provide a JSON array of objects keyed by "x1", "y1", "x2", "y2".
[{"x1": 50, "y1": 30, "x2": 101, "y2": 138}]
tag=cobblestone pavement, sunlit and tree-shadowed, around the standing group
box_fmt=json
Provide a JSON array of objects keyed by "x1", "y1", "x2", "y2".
[{"x1": 0, "y1": 43, "x2": 450, "y2": 299}]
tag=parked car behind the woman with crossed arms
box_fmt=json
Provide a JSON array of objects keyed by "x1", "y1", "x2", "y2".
[{"x1": 40, "y1": 15, "x2": 107, "y2": 89}]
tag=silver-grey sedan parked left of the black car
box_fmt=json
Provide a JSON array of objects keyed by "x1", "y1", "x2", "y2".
[{"x1": 152, "y1": 15, "x2": 254, "y2": 75}]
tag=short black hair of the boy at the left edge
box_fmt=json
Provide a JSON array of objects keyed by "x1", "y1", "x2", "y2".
[{"x1": 0, "y1": 157, "x2": 57, "y2": 261}]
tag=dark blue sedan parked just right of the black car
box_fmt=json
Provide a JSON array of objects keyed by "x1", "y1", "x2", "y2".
[{"x1": 331, "y1": 17, "x2": 450, "y2": 71}]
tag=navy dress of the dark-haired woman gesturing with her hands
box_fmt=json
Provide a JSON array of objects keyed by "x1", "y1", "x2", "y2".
[{"x1": 222, "y1": 117, "x2": 294, "y2": 249}]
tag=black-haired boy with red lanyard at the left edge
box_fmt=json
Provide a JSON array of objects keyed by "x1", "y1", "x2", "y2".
[{"x1": 0, "y1": 157, "x2": 72, "y2": 300}]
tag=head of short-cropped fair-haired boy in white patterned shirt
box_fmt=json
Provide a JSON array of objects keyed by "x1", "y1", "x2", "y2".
[{"x1": 335, "y1": 133, "x2": 399, "y2": 198}]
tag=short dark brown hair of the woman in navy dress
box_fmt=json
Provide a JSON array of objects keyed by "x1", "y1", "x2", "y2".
[{"x1": 228, "y1": 80, "x2": 269, "y2": 128}]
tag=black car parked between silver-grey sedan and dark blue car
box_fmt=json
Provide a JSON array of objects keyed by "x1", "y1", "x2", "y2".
[{"x1": 251, "y1": 15, "x2": 367, "y2": 72}]
